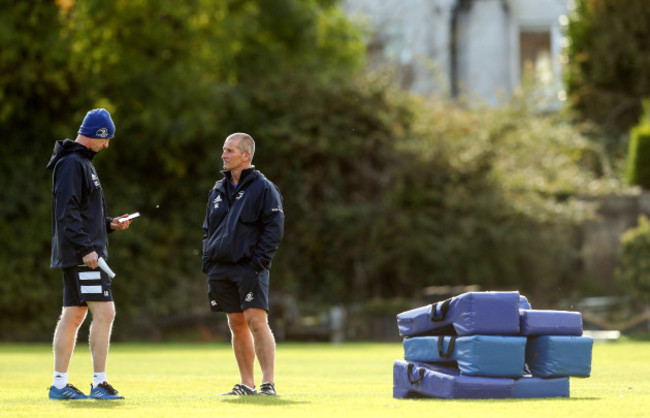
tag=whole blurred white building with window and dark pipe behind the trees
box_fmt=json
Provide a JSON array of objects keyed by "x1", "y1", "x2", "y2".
[{"x1": 342, "y1": 0, "x2": 569, "y2": 109}]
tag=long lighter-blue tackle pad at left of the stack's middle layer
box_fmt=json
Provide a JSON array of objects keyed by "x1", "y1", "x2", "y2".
[{"x1": 403, "y1": 335, "x2": 526, "y2": 378}]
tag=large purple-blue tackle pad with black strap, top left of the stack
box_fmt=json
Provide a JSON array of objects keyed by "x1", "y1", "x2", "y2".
[{"x1": 397, "y1": 291, "x2": 530, "y2": 337}]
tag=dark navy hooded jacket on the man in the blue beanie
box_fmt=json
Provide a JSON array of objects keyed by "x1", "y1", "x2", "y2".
[{"x1": 47, "y1": 139, "x2": 112, "y2": 268}]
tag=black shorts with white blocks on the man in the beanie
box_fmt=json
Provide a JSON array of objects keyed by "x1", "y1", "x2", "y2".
[{"x1": 63, "y1": 266, "x2": 113, "y2": 306}]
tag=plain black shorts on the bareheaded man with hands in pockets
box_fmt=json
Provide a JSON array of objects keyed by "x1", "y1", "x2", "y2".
[{"x1": 208, "y1": 263, "x2": 269, "y2": 313}]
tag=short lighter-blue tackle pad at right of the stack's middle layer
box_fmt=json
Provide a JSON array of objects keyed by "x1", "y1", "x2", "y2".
[{"x1": 526, "y1": 335, "x2": 594, "y2": 377}]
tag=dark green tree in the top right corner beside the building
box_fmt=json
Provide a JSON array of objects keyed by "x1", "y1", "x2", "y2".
[{"x1": 566, "y1": 0, "x2": 650, "y2": 132}]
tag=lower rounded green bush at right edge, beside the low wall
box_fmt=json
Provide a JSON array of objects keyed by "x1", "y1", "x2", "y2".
[{"x1": 616, "y1": 215, "x2": 650, "y2": 301}]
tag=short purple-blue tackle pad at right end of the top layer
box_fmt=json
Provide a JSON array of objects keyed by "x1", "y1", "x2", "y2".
[{"x1": 519, "y1": 309, "x2": 582, "y2": 336}]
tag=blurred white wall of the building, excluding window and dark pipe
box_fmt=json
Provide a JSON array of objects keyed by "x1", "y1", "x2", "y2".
[{"x1": 342, "y1": 0, "x2": 570, "y2": 105}]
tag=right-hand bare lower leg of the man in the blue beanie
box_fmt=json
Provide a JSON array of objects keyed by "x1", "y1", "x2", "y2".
[{"x1": 88, "y1": 302, "x2": 115, "y2": 373}]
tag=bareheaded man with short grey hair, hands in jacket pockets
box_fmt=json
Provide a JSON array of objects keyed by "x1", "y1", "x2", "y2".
[{"x1": 202, "y1": 133, "x2": 284, "y2": 395}]
